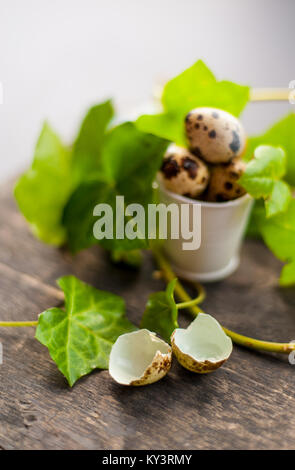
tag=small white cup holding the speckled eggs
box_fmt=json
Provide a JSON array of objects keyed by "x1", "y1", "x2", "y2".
[{"x1": 158, "y1": 181, "x2": 253, "y2": 282}]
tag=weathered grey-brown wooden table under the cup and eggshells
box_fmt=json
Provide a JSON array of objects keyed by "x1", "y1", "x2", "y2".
[{"x1": 0, "y1": 184, "x2": 295, "y2": 449}]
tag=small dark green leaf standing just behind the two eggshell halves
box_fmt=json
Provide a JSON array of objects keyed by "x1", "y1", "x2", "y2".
[{"x1": 140, "y1": 279, "x2": 178, "y2": 342}]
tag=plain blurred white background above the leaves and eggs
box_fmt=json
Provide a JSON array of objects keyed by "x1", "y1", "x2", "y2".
[{"x1": 0, "y1": 0, "x2": 295, "y2": 180}]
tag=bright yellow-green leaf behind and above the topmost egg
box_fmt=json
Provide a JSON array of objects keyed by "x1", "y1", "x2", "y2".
[{"x1": 136, "y1": 60, "x2": 249, "y2": 145}]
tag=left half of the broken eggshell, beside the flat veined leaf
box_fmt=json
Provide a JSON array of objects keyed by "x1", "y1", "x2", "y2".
[{"x1": 109, "y1": 329, "x2": 172, "y2": 385}]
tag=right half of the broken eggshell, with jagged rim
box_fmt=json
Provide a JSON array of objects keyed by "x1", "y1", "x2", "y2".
[{"x1": 171, "y1": 313, "x2": 233, "y2": 374}]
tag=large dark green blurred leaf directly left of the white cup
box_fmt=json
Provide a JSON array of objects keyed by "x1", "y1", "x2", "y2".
[{"x1": 63, "y1": 122, "x2": 167, "y2": 252}]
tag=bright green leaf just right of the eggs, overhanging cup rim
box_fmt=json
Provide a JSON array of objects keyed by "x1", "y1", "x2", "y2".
[{"x1": 240, "y1": 145, "x2": 292, "y2": 217}]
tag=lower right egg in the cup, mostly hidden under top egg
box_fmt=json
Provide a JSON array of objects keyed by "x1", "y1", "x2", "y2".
[{"x1": 207, "y1": 158, "x2": 246, "y2": 202}]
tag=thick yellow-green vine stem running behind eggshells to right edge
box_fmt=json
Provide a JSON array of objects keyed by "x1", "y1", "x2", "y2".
[{"x1": 153, "y1": 249, "x2": 295, "y2": 354}]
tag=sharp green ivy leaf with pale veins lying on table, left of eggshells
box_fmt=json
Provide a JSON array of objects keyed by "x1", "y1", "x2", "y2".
[{"x1": 36, "y1": 276, "x2": 136, "y2": 386}]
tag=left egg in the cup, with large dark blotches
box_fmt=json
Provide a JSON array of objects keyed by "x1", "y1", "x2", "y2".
[{"x1": 160, "y1": 144, "x2": 209, "y2": 198}]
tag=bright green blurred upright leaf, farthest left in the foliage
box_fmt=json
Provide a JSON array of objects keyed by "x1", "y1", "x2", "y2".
[{"x1": 14, "y1": 124, "x2": 72, "y2": 245}]
